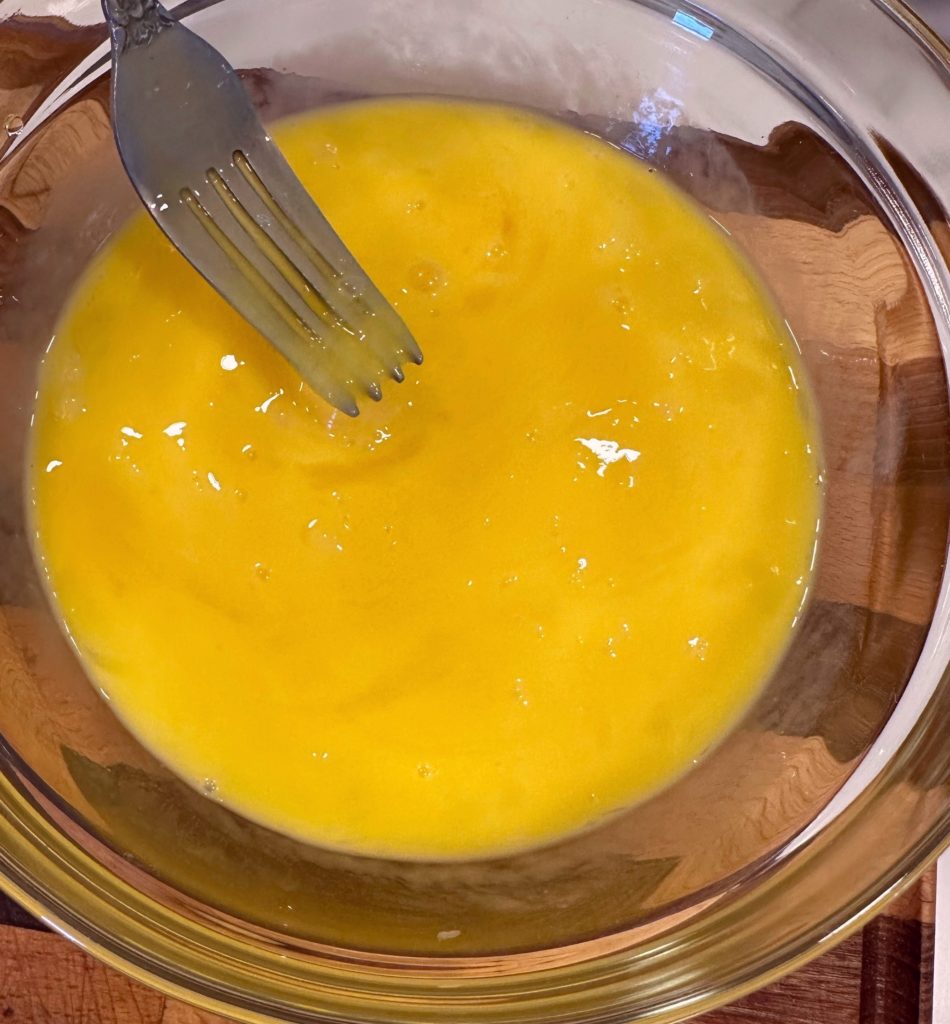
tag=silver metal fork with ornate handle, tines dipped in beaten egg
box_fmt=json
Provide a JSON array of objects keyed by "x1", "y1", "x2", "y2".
[{"x1": 102, "y1": 0, "x2": 422, "y2": 416}]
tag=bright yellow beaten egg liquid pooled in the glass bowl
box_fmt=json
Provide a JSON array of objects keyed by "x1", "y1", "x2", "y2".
[{"x1": 32, "y1": 99, "x2": 819, "y2": 859}]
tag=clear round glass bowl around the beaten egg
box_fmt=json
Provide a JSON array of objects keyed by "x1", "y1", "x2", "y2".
[{"x1": 0, "y1": 0, "x2": 950, "y2": 1024}]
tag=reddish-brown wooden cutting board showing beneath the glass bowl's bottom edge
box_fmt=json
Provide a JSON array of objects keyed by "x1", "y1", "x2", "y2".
[{"x1": 0, "y1": 870, "x2": 936, "y2": 1024}]
